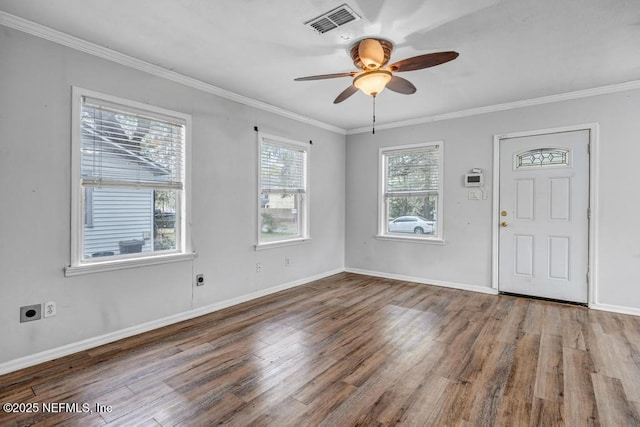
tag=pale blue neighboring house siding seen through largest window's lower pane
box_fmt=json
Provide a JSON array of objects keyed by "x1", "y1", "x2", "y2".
[{"x1": 84, "y1": 187, "x2": 153, "y2": 257}]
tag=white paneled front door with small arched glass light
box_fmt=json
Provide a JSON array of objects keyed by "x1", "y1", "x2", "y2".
[{"x1": 496, "y1": 130, "x2": 589, "y2": 303}]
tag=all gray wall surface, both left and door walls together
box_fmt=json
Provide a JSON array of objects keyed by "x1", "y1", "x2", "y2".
[{"x1": 0, "y1": 26, "x2": 640, "y2": 370}]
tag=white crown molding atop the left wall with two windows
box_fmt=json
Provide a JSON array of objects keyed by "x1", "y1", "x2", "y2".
[{"x1": 0, "y1": 11, "x2": 346, "y2": 135}]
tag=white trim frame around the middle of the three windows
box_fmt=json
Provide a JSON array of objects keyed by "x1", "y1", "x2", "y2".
[{"x1": 254, "y1": 131, "x2": 311, "y2": 250}]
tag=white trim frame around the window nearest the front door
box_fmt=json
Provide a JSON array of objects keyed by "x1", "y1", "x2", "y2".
[{"x1": 375, "y1": 140, "x2": 445, "y2": 244}]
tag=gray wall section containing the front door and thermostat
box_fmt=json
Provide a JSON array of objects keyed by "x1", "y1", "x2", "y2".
[{"x1": 346, "y1": 90, "x2": 640, "y2": 314}]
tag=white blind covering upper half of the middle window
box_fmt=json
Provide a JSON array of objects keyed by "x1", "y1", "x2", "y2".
[{"x1": 260, "y1": 139, "x2": 306, "y2": 194}]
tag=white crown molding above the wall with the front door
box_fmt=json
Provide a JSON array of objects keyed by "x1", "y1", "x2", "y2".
[{"x1": 347, "y1": 80, "x2": 640, "y2": 135}]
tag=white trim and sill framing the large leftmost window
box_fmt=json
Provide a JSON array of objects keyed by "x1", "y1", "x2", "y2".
[{"x1": 64, "y1": 86, "x2": 197, "y2": 276}]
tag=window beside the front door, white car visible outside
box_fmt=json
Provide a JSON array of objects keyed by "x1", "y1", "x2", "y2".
[{"x1": 379, "y1": 142, "x2": 442, "y2": 240}]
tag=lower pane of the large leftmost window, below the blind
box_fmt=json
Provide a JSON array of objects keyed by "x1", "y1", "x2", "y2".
[{"x1": 82, "y1": 187, "x2": 177, "y2": 259}]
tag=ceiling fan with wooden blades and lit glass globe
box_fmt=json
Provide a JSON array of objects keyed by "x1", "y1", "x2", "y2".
[{"x1": 294, "y1": 38, "x2": 458, "y2": 105}]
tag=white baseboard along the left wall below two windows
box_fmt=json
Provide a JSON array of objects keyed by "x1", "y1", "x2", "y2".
[{"x1": 0, "y1": 268, "x2": 344, "y2": 375}]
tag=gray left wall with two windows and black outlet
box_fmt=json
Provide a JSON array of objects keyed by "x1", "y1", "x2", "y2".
[{"x1": 0, "y1": 26, "x2": 345, "y2": 365}]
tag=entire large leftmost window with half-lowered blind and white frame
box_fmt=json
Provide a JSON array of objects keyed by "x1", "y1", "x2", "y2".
[{"x1": 67, "y1": 88, "x2": 190, "y2": 275}]
